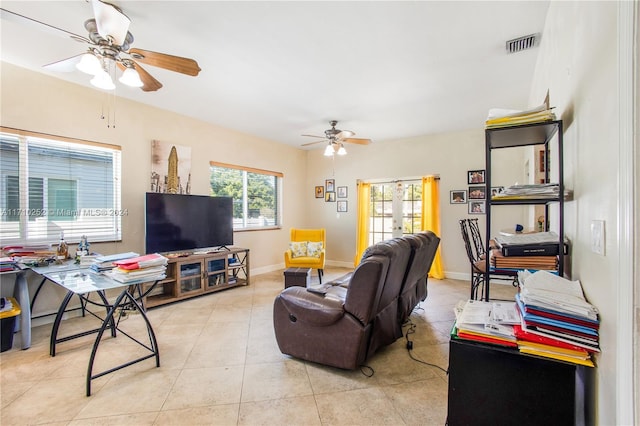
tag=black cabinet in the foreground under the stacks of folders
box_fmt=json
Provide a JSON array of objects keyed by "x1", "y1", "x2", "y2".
[{"x1": 447, "y1": 339, "x2": 594, "y2": 426}]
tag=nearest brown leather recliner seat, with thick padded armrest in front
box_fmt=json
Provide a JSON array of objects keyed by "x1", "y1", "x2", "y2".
[{"x1": 273, "y1": 238, "x2": 411, "y2": 369}]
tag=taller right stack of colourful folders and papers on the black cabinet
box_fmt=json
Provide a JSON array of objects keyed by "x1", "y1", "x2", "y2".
[{"x1": 514, "y1": 271, "x2": 600, "y2": 367}]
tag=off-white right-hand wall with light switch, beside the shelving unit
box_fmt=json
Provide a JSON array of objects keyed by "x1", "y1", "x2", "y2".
[{"x1": 531, "y1": 2, "x2": 637, "y2": 425}]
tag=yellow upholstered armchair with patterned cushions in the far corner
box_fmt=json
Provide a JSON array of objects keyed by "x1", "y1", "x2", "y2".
[{"x1": 284, "y1": 228, "x2": 327, "y2": 283}]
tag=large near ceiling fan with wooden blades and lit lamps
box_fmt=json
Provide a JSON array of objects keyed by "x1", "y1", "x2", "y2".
[{"x1": 0, "y1": 0, "x2": 200, "y2": 92}]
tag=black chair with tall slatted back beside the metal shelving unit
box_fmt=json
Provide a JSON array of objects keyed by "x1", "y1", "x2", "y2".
[{"x1": 460, "y1": 219, "x2": 518, "y2": 300}]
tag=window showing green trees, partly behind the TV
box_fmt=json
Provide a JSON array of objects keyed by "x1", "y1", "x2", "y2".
[{"x1": 210, "y1": 162, "x2": 283, "y2": 230}]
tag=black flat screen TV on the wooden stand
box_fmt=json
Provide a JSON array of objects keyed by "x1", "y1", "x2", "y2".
[{"x1": 145, "y1": 192, "x2": 233, "y2": 253}]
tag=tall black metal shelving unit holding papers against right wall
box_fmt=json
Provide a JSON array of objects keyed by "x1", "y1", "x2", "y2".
[{"x1": 483, "y1": 120, "x2": 565, "y2": 301}]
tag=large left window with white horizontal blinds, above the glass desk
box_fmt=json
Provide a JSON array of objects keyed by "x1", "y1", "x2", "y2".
[{"x1": 0, "y1": 128, "x2": 122, "y2": 245}]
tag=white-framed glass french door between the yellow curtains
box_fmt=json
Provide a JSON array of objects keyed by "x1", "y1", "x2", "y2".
[{"x1": 369, "y1": 180, "x2": 422, "y2": 245}]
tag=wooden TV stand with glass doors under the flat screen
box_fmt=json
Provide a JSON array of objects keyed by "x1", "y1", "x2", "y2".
[{"x1": 143, "y1": 247, "x2": 250, "y2": 308}]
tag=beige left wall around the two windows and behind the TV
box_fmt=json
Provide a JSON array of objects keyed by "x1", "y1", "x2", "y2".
[{"x1": 0, "y1": 63, "x2": 306, "y2": 315}]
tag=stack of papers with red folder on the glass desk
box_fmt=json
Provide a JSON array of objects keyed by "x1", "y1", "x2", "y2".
[{"x1": 105, "y1": 253, "x2": 169, "y2": 284}]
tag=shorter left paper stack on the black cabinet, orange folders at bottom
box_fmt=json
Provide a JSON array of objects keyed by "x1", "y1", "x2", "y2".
[{"x1": 451, "y1": 300, "x2": 520, "y2": 348}]
